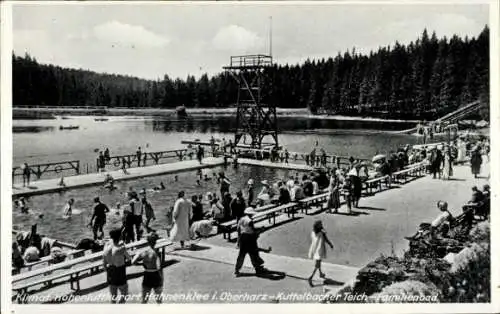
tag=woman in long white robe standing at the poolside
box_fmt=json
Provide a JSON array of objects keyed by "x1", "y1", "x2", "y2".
[{"x1": 170, "y1": 191, "x2": 193, "y2": 247}]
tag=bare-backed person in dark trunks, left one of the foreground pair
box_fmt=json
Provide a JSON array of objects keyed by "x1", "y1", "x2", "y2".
[{"x1": 102, "y1": 229, "x2": 131, "y2": 304}]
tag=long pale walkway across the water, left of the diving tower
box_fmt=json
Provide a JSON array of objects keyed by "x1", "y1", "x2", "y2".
[{"x1": 12, "y1": 157, "x2": 224, "y2": 197}]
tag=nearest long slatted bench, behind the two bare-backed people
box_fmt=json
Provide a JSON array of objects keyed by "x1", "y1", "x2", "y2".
[{"x1": 12, "y1": 239, "x2": 172, "y2": 301}]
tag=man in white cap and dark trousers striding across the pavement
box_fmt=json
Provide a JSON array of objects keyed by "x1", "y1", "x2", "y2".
[{"x1": 234, "y1": 207, "x2": 271, "y2": 276}]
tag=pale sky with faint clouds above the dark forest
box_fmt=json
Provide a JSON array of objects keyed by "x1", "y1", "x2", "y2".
[{"x1": 13, "y1": 2, "x2": 489, "y2": 79}]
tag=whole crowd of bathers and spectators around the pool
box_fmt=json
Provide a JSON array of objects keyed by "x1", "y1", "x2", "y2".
[{"x1": 12, "y1": 134, "x2": 490, "y2": 302}]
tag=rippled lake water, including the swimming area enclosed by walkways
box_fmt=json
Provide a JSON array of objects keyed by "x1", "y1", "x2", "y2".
[{"x1": 13, "y1": 116, "x2": 430, "y2": 242}]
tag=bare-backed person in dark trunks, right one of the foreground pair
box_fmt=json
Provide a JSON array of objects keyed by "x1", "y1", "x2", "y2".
[{"x1": 132, "y1": 233, "x2": 163, "y2": 304}]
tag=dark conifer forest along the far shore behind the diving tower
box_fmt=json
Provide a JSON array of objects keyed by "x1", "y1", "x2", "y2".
[{"x1": 13, "y1": 26, "x2": 489, "y2": 119}]
